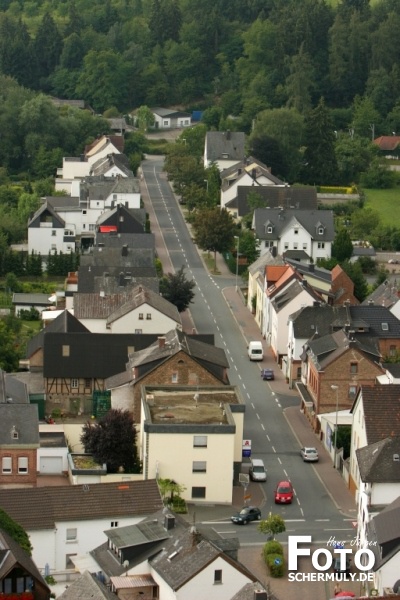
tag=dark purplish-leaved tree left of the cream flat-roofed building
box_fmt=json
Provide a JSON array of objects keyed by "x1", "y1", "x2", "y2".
[{"x1": 80, "y1": 409, "x2": 140, "y2": 473}]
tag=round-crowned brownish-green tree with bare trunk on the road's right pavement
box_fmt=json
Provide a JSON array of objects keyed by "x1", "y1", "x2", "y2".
[{"x1": 192, "y1": 207, "x2": 237, "y2": 270}]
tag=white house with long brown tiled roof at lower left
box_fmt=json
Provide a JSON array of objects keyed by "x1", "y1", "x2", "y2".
[{"x1": 0, "y1": 480, "x2": 162, "y2": 574}]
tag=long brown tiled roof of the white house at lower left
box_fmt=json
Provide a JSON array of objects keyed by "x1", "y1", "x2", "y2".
[{"x1": 0, "y1": 479, "x2": 162, "y2": 531}]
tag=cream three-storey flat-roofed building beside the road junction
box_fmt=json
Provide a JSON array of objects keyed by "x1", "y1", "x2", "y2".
[{"x1": 140, "y1": 386, "x2": 245, "y2": 504}]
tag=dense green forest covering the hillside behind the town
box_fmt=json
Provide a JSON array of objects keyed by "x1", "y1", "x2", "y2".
[{"x1": 0, "y1": 0, "x2": 400, "y2": 124}]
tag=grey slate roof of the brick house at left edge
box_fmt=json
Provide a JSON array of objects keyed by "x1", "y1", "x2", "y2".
[{"x1": 0, "y1": 403, "x2": 39, "y2": 446}]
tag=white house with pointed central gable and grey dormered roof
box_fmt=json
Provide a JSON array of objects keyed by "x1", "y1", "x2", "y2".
[{"x1": 252, "y1": 208, "x2": 335, "y2": 262}]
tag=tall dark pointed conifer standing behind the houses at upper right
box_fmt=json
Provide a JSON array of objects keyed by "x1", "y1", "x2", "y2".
[{"x1": 302, "y1": 98, "x2": 337, "y2": 185}]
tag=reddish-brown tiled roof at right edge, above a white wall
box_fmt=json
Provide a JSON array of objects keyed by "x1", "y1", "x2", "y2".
[{"x1": 360, "y1": 384, "x2": 400, "y2": 444}]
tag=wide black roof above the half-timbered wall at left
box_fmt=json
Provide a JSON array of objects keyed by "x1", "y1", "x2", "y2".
[{"x1": 43, "y1": 333, "x2": 166, "y2": 379}]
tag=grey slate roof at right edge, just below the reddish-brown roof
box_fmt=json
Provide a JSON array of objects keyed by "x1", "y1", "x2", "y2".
[{"x1": 356, "y1": 435, "x2": 400, "y2": 483}]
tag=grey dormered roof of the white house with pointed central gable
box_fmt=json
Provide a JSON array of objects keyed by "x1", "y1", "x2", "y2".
[{"x1": 253, "y1": 208, "x2": 335, "y2": 242}]
